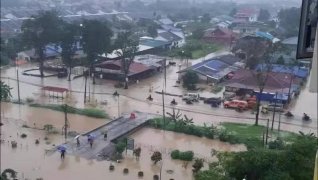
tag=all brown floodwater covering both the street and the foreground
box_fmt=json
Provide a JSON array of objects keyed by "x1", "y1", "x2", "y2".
[{"x1": 1, "y1": 51, "x2": 317, "y2": 180}]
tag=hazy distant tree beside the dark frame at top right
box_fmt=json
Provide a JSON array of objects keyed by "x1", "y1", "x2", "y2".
[{"x1": 278, "y1": 7, "x2": 300, "y2": 37}]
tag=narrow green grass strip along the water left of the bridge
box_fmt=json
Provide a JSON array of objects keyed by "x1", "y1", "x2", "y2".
[{"x1": 29, "y1": 104, "x2": 108, "y2": 118}]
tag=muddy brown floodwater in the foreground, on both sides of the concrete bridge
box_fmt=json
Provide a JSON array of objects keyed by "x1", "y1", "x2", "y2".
[{"x1": 1, "y1": 103, "x2": 246, "y2": 180}]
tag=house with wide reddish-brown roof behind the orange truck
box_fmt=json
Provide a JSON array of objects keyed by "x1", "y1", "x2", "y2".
[{"x1": 225, "y1": 69, "x2": 298, "y2": 102}]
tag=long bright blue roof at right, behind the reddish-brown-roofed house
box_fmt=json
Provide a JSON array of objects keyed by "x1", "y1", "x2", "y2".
[{"x1": 256, "y1": 64, "x2": 309, "y2": 78}]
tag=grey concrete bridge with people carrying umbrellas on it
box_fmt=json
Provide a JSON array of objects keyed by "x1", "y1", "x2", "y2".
[{"x1": 56, "y1": 112, "x2": 158, "y2": 160}]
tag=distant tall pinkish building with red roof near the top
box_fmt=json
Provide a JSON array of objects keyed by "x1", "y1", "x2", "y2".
[{"x1": 234, "y1": 8, "x2": 259, "y2": 23}]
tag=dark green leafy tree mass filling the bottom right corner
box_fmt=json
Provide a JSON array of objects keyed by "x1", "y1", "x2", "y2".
[{"x1": 219, "y1": 136, "x2": 318, "y2": 180}]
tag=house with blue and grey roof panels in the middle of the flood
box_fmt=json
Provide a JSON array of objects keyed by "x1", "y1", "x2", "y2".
[{"x1": 177, "y1": 55, "x2": 244, "y2": 83}]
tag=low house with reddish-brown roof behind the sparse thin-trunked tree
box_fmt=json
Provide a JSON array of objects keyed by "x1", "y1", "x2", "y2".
[{"x1": 94, "y1": 60, "x2": 156, "y2": 81}]
